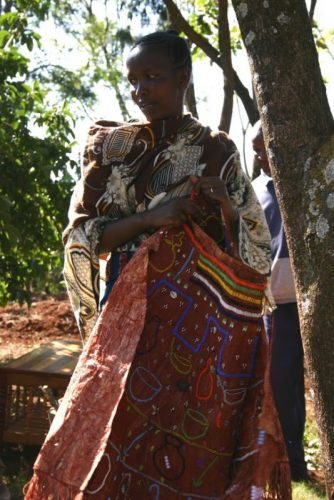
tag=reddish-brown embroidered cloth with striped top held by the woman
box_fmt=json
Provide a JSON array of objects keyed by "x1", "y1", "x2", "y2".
[{"x1": 26, "y1": 228, "x2": 290, "y2": 500}]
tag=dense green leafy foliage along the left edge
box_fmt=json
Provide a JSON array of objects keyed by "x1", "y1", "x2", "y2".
[{"x1": 0, "y1": 1, "x2": 75, "y2": 303}]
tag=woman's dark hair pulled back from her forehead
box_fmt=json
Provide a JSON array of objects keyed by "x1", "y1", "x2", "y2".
[{"x1": 132, "y1": 30, "x2": 192, "y2": 73}]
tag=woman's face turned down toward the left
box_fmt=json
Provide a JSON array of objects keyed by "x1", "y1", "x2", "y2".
[{"x1": 127, "y1": 45, "x2": 189, "y2": 121}]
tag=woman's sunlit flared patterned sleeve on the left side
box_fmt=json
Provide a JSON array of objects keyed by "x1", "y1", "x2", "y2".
[{"x1": 63, "y1": 122, "x2": 124, "y2": 340}]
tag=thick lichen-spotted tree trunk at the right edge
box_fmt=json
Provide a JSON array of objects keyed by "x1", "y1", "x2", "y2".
[{"x1": 233, "y1": 0, "x2": 334, "y2": 491}]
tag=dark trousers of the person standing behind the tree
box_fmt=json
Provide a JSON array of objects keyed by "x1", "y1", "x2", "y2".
[{"x1": 264, "y1": 303, "x2": 306, "y2": 480}]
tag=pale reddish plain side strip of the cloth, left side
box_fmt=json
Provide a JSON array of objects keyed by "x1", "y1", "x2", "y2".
[{"x1": 24, "y1": 232, "x2": 158, "y2": 500}]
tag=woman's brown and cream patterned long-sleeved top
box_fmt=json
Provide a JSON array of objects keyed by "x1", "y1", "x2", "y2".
[{"x1": 64, "y1": 115, "x2": 271, "y2": 336}]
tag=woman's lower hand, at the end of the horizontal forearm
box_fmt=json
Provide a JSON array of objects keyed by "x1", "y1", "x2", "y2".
[{"x1": 143, "y1": 198, "x2": 203, "y2": 229}]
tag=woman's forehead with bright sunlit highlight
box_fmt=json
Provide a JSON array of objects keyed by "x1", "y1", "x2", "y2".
[{"x1": 126, "y1": 45, "x2": 172, "y2": 71}]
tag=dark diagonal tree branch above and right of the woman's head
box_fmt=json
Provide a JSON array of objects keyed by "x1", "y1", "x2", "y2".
[{"x1": 163, "y1": 0, "x2": 259, "y2": 125}]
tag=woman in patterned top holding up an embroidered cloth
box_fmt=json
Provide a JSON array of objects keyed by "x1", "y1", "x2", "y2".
[{"x1": 26, "y1": 32, "x2": 289, "y2": 499}]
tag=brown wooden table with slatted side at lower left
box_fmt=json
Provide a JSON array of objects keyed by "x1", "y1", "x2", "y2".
[{"x1": 0, "y1": 340, "x2": 82, "y2": 445}]
